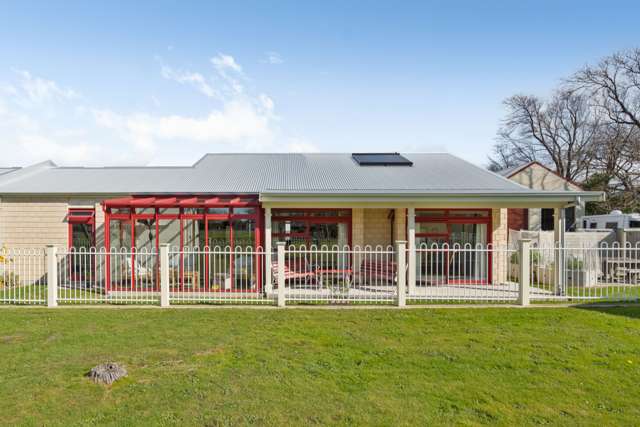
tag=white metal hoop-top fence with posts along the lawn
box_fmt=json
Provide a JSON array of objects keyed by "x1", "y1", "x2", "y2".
[{"x1": 0, "y1": 241, "x2": 640, "y2": 306}]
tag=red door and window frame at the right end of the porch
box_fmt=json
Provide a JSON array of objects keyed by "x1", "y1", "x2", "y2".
[{"x1": 415, "y1": 208, "x2": 493, "y2": 285}]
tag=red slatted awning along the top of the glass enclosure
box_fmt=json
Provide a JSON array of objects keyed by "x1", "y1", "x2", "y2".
[{"x1": 102, "y1": 195, "x2": 258, "y2": 208}]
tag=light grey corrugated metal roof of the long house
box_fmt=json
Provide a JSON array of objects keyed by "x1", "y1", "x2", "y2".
[{"x1": 0, "y1": 153, "x2": 548, "y2": 194}]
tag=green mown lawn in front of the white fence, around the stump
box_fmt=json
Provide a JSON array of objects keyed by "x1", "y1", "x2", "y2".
[{"x1": 0, "y1": 306, "x2": 640, "y2": 426}]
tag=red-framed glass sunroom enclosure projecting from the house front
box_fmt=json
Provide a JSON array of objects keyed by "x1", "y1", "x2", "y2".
[{"x1": 105, "y1": 196, "x2": 260, "y2": 291}]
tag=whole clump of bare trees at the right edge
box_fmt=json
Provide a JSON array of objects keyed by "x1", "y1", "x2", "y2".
[{"x1": 489, "y1": 49, "x2": 640, "y2": 213}]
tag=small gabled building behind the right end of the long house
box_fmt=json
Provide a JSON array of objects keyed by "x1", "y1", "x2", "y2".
[{"x1": 498, "y1": 161, "x2": 586, "y2": 231}]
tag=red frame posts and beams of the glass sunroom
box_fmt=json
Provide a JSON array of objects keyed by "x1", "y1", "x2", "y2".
[{"x1": 102, "y1": 195, "x2": 263, "y2": 292}]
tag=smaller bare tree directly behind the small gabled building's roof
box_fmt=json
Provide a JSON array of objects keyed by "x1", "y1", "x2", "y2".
[{"x1": 490, "y1": 90, "x2": 598, "y2": 180}]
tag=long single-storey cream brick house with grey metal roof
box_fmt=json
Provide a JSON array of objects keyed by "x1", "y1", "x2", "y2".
[{"x1": 0, "y1": 153, "x2": 603, "y2": 294}]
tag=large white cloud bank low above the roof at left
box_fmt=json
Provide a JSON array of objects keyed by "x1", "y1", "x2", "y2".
[{"x1": 0, "y1": 54, "x2": 302, "y2": 166}]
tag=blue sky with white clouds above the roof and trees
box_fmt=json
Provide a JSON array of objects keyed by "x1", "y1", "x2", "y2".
[{"x1": 0, "y1": 0, "x2": 640, "y2": 167}]
